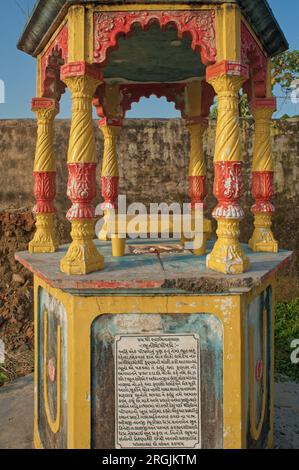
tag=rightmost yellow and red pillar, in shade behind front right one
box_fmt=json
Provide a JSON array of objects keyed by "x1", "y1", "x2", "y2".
[{"x1": 249, "y1": 98, "x2": 278, "y2": 253}]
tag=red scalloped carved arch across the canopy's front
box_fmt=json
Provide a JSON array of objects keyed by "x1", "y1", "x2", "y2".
[{"x1": 94, "y1": 10, "x2": 217, "y2": 65}]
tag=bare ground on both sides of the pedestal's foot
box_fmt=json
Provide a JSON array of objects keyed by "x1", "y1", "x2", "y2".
[{"x1": 0, "y1": 375, "x2": 299, "y2": 449}]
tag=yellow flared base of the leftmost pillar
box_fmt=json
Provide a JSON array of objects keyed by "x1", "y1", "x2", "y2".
[{"x1": 28, "y1": 214, "x2": 59, "y2": 253}]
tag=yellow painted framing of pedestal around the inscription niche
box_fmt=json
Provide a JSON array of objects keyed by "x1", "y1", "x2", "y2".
[{"x1": 34, "y1": 276, "x2": 275, "y2": 449}]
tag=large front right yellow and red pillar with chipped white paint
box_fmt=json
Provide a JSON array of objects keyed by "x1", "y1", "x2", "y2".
[{"x1": 207, "y1": 61, "x2": 249, "y2": 274}]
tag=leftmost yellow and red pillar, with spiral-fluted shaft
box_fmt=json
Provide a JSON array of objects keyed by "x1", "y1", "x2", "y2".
[{"x1": 29, "y1": 98, "x2": 58, "y2": 253}]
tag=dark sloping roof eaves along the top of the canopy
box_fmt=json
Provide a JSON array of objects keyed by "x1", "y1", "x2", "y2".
[{"x1": 18, "y1": 0, "x2": 288, "y2": 57}]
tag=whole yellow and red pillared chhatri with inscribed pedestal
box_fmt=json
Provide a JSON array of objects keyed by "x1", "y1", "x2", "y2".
[{"x1": 16, "y1": 0, "x2": 291, "y2": 449}]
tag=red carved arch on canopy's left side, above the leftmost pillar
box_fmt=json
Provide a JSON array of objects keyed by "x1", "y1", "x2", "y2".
[{"x1": 41, "y1": 24, "x2": 68, "y2": 101}]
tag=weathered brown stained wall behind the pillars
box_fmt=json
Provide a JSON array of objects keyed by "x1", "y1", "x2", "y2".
[{"x1": 0, "y1": 119, "x2": 299, "y2": 286}]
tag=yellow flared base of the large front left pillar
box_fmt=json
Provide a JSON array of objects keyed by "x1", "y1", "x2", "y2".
[{"x1": 60, "y1": 220, "x2": 105, "y2": 275}]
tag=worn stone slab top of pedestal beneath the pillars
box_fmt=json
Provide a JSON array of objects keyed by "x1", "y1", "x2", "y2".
[{"x1": 15, "y1": 240, "x2": 293, "y2": 295}]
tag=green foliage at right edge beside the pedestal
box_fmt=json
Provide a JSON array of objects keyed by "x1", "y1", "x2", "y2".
[{"x1": 275, "y1": 298, "x2": 299, "y2": 382}]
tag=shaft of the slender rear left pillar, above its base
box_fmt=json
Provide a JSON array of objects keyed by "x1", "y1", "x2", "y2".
[{"x1": 99, "y1": 118, "x2": 121, "y2": 211}]
